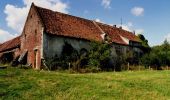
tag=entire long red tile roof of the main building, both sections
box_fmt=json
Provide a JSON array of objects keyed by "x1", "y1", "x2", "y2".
[{"x1": 35, "y1": 6, "x2": 140, "y2": 45}]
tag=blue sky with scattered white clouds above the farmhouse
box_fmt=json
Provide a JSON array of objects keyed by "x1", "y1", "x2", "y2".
[{"x1": 0, "y1": 0, "x2": 170, "y2": 46}]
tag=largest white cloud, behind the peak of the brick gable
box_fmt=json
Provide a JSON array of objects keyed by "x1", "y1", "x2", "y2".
[{"x1": 4, "y1": 0, "x2": 68, "y2": 34}]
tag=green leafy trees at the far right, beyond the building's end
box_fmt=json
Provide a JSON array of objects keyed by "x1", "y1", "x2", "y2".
[{"x1": 141, "y1": 40, "x2": 170, "y2": 69}]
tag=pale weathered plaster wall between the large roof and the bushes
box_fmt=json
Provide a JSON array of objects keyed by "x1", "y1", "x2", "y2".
[{"x1": 43, "y1": 34, "x2": 90, "y2": 58}]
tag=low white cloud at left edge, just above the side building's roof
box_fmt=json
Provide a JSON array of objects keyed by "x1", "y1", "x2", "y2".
[{"x1": 0, "y1": 29, "x2": 17, "y2": 43}]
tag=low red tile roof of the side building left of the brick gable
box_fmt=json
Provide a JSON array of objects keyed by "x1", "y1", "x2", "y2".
[{"x1": 0, "y1": 36, "x2": 21, "y2": 52}]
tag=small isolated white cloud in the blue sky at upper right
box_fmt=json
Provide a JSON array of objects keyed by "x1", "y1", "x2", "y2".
[{"x1": 131, "y1": 7, "x2": 144, "y2": 16}]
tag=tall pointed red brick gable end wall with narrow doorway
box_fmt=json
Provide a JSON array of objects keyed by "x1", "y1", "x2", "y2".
[{"x1": 21, "y1": 5, "x2": 42, "y2": 69}]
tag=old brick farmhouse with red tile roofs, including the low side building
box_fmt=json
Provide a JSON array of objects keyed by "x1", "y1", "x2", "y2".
[{"x1": 0, "y1": 4, "x2": 142, "y2": 69}]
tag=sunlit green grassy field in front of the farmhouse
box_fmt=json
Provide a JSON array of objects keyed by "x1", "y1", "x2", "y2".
[{"x1": 0, "y1": 68, "x2": 170, "y2": 100}]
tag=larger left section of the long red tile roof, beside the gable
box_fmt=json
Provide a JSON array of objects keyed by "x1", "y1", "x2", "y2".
[{"x1": 35, "y1": 6, "x2": 102, "y2": 41}]
